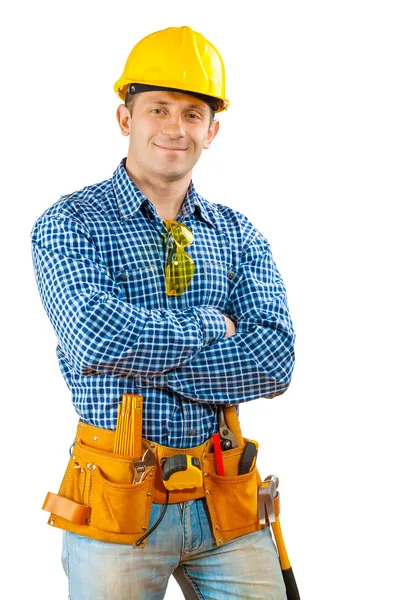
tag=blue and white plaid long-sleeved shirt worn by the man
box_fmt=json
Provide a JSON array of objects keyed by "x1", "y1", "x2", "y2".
[{"x1": 32, "y1": 158, "x2": 295, "y2": 448}]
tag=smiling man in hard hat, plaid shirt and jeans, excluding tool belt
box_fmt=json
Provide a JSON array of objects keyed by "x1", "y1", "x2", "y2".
[{"x1": 32, "y1": 27, "x2": 294, "y2": 600}]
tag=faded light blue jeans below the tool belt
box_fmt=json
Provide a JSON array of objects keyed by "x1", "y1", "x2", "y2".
[{"x1": 62, "y1": 499, "x2": 286, "y2": 600}]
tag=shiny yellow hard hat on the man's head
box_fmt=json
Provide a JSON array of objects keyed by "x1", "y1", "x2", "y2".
[{"x1": 114, "y1": 26, "x2": 229, "y2": 112}]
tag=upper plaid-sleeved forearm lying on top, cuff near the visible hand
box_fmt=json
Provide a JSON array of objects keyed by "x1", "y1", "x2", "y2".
[{"x1": 71, "y1": 300, "x2": 224, "y2": 376}]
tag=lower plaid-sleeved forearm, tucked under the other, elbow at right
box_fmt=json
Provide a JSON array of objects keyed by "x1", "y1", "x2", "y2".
[{"x1": 138, "y1": 318, "x2": 294, "y2": 404}]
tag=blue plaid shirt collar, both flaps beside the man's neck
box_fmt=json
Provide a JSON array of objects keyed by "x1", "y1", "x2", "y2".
[{"x1": 112, "y1": 157, "x2": 217, "y2": 227}]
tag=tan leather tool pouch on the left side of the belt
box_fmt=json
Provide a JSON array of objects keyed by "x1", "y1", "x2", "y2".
[{"x1": 43, "y1": 423, "x2": 155, "y2": 546}]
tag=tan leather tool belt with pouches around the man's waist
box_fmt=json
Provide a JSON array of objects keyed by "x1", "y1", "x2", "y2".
[{"x1": 43, "y1": 418, "x2": 268, "y2": 547}]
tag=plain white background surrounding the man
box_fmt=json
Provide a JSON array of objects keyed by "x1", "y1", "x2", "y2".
[{"x1": 0, "y1": 0, "x2": 400, "y2": 600}]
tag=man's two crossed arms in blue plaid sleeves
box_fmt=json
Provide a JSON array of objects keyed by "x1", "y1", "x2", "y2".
[{"x1": 32, "y1": 216, "x2": 294, "y2": 403}]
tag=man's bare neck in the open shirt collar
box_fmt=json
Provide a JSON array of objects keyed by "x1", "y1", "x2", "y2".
[{"x1": 125, "y1": 156, "x2": 192, "y2": 220}]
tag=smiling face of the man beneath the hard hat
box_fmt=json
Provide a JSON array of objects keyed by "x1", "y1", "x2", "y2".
[{"x1": 117, "y1": 91, "x2": 219, "y2": 181}]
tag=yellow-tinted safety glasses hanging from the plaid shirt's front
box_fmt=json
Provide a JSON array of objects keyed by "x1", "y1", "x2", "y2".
[{"x1": 164, "y1": 219, "x2": 195, "y2": 296}]
